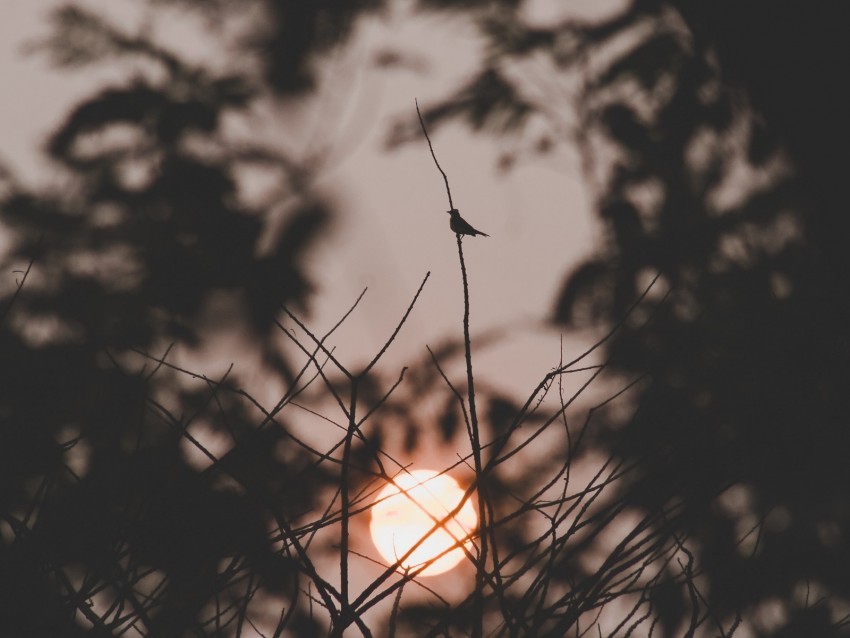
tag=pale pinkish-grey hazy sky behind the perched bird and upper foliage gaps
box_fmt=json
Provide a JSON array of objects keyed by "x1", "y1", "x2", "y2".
[{"x1": 0, "y1": 0, "x2": 616, "y2": 404}]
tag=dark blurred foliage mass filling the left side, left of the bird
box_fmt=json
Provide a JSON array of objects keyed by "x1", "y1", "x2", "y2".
[{"x1": 0, "y1": 1, "x2": 350, "y2": 636}]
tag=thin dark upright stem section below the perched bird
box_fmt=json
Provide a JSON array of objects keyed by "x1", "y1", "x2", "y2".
[{"x1": 457, "y1": 234, "x2": 488, "y2": 638}]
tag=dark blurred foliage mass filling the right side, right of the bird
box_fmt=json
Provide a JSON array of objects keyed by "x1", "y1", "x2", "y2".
[{"x1": 408, "y1": 2, "x2": 850, "y2": 636}]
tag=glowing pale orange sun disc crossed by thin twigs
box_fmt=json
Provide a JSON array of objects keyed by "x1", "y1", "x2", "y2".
[{"x1": 369, "y1": 470, "x2": 478, "y2": 576}]
